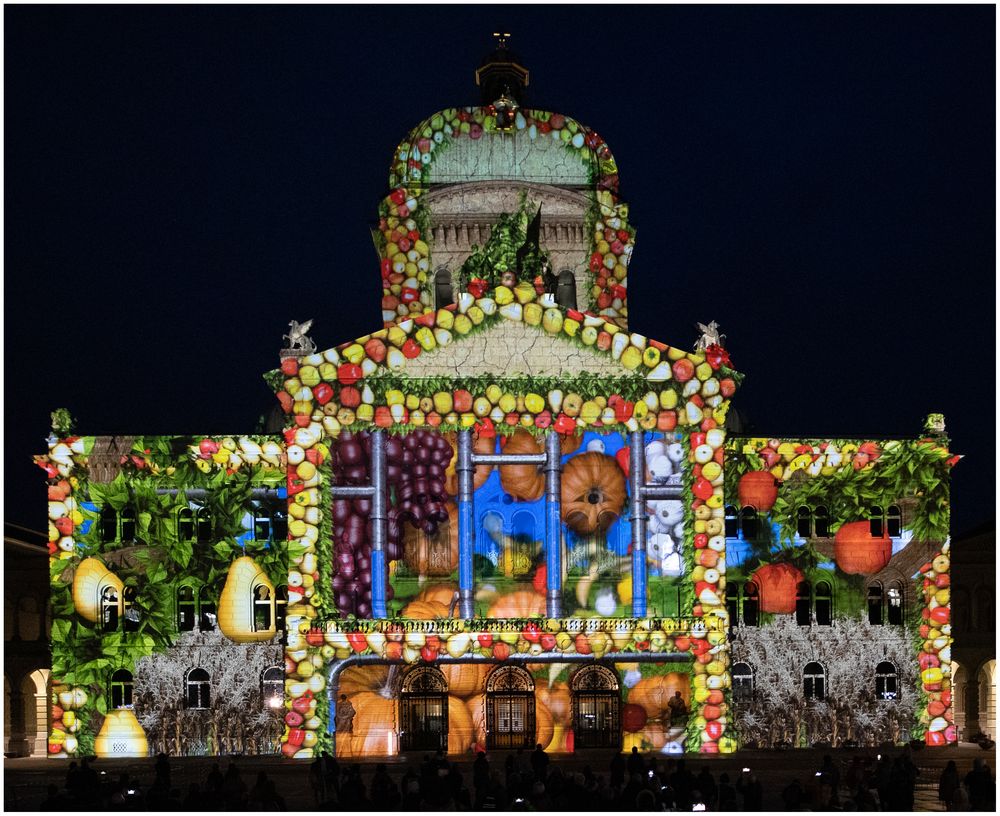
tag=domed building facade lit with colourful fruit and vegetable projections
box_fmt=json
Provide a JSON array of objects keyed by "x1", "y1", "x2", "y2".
[{"x1": 38, "y1": 45, "x2": 956, "y2": 759}]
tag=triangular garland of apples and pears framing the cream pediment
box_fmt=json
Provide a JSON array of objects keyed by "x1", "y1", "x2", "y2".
[{"x1": 267, "y1": 302, "x2": 740, "y2": 437}]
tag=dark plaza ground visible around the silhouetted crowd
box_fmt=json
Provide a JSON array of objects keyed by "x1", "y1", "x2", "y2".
[{"x1": 4, "y1": 743, "x2": 996, "y2": 811}]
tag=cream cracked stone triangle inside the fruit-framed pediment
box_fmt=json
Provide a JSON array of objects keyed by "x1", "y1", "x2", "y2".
[{"x1": 403, "y1": 320, "x2": 629, "y2": 377}]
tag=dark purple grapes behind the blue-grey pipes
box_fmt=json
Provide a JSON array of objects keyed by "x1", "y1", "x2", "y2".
[{"x1": 331, "y1": 430, "x2": 453, "y2": 618}]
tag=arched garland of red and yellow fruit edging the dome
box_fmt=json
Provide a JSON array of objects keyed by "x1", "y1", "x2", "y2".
[{"x1": 379, "y1": 106, "x2": 635, "y2": 327}]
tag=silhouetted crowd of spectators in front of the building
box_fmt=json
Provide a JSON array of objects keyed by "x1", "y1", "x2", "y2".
[{"x1": 12, "y1": 746, "x2": 995, "y2": 812}]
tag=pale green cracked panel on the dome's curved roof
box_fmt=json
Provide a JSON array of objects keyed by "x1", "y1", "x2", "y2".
[{"x1": 430, "y1": 130, "x2": 590, "y2": 184}]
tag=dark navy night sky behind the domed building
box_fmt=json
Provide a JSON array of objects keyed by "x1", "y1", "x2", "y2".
[{"x1": 4, "y1": 5, "x2": 996, "y2": 533}]
